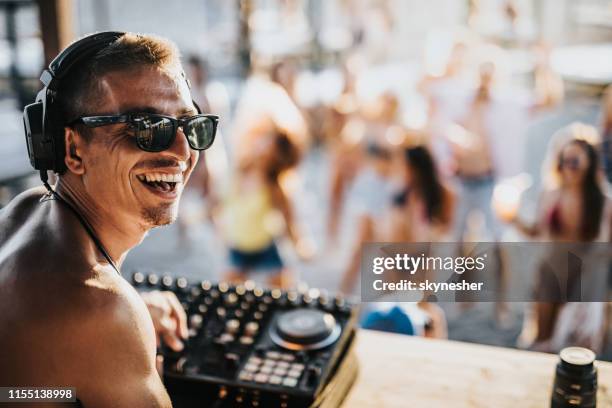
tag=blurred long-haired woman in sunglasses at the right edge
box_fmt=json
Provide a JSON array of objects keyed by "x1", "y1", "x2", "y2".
[{"x1": 506, "y1": 123, "x2": 612, "y2": 352}]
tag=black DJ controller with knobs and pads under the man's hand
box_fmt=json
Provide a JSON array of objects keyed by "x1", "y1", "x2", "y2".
[{"x1": 132, "y1": 272, "x2": 357, "y2": 408}]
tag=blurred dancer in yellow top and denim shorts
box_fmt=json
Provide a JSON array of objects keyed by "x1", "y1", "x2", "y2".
[{"x1": 221, "y1": 127, "x2": 301, "y2": 287}]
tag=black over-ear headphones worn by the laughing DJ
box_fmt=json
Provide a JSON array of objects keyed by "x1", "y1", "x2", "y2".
[{"x1": 23, "y1": 31, "x2": 125, "y2": 181}]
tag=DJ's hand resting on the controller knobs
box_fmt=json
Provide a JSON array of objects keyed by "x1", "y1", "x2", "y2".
[{"x1": 140, "y1": 290, "x2": 188, "y2": 351}]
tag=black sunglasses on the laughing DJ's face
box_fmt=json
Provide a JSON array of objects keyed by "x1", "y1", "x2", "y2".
[{"x1": 71, "y1": 113, "x2": 219, "y2": 152}]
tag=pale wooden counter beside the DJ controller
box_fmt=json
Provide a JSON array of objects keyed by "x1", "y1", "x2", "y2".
[{"x1": 343, "y1": 330, "x2": 612, "y2": 408}]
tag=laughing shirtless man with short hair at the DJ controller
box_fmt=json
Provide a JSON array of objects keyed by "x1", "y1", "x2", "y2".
[{"x1": 0, "y1": 33, "x2": 214, "y2": 407}]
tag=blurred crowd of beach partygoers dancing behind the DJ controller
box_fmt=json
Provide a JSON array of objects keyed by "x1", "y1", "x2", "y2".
[{"x1": 171, "y1": 1, "x2": 612, "y2": 351}]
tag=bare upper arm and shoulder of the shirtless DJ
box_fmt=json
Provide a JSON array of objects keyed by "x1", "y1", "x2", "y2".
[{"x1": 68, "y1": 284, "x2": 171, "y2": 408}]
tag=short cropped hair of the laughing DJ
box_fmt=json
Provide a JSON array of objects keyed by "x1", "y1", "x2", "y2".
[{"x1": 58, "y1": 33, "x2": 181, "y2": 123}]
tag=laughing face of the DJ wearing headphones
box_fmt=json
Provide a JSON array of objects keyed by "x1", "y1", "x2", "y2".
[{"x1": 74, "y1": 67, "x2": 199, "y2": 230}]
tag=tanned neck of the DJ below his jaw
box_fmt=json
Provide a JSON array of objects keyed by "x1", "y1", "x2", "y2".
[{"x1": 55, "y1": 178, "x2": 146, "y2": 267}]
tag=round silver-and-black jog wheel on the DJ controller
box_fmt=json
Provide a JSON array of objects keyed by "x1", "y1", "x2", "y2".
[{"x1": 270, "y1": 309, "x2": 341, "y2": 351}]
